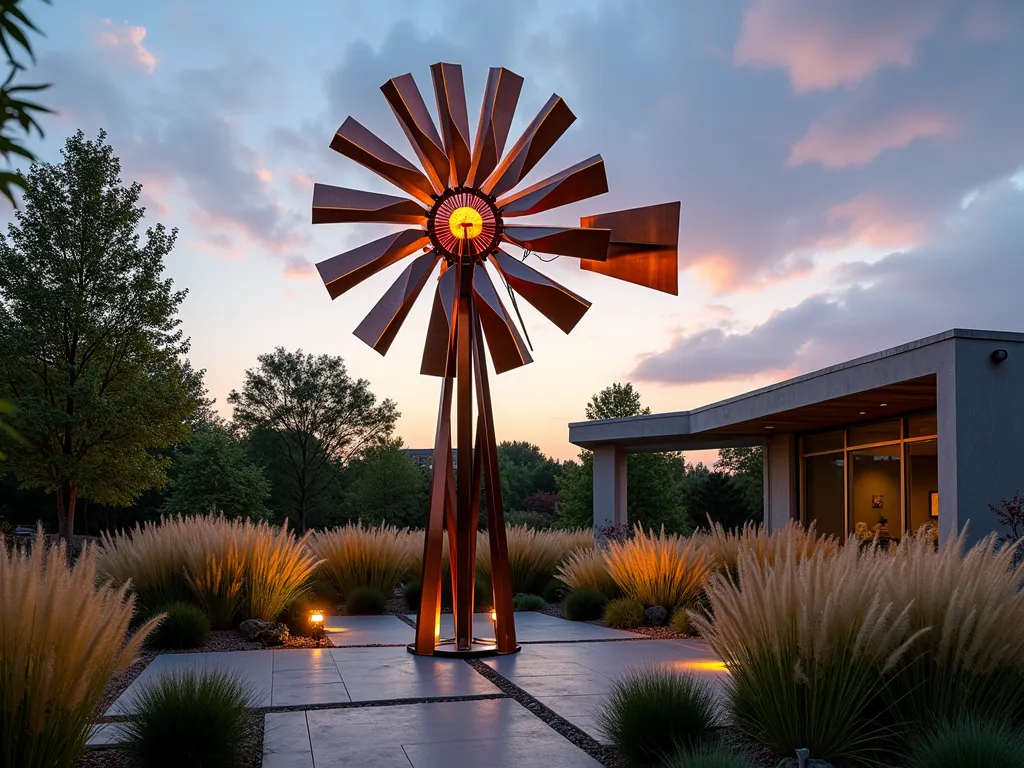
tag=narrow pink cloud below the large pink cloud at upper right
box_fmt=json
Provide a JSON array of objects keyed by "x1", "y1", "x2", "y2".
[{"x1": 786, "y1": 113, "x2": 955, "y2": 168}]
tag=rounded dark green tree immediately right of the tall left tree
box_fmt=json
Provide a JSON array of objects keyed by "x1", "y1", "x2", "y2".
[{"x1": 163, "y1": 424, "x2": 270, "y2": 518}]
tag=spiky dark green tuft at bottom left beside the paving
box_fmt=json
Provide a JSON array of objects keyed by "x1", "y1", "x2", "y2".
[{"x1": 120, "y1": 670, "x2": 256, "y2": 768}]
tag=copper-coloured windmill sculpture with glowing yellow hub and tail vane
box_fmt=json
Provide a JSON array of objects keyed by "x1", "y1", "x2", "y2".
[{"x1": 312, "y1": 63, "x2": 679, "y2": 656}]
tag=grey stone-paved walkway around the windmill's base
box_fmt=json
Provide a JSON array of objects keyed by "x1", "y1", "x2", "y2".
[{"x1": 89, "y1": 612, "x2": 727, "y2": 768}]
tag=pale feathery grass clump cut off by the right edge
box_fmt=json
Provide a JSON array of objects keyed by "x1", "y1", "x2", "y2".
[{"x1": 882, "y1": 532, "x2": 1024, "y2": 729}]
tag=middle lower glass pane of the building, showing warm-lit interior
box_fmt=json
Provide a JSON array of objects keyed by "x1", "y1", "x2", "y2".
[{"x1": 849, "y1": 445, "x2": 903, "y2": 539}]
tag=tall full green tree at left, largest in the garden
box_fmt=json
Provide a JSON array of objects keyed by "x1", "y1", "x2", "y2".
[{"x1": 0, "y1": 131, "x2": 204, "y2": 541}]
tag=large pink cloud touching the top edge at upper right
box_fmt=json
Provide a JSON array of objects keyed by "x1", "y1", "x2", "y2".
[{"x1": 733, "y1": 0, "x2": 942, "y2": 93}]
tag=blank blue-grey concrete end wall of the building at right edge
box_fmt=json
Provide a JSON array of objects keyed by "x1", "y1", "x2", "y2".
[{"x1": 939, "y1": 339, "x2": 1024, "y2": 542}]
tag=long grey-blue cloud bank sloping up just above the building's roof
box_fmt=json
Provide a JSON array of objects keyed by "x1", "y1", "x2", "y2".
[{"x1": 633, "y1": 181, "x2": 1024, "y2": 384}]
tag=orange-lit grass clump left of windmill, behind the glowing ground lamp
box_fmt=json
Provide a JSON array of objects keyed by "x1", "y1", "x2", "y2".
[{"x1": 240, "y1": 520, "x2": 319, "y2": 622}]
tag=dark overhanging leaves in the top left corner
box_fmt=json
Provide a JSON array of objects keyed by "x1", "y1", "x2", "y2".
[{"x1": 0, "y1": 0, "x2": 50, "y2": 205}]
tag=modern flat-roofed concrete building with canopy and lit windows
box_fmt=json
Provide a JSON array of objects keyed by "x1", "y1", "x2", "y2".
[{"x1": 569, "y1": 329, "x2": 1024, "y2": 541}]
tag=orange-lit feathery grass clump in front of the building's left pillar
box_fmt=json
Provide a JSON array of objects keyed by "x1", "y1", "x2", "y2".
[{"x1": 604, "y1": 525, "x2": 711, "y2": 611}]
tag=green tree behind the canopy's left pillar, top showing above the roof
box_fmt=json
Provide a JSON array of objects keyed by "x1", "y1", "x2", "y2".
[{"x1": 558, "y1": 382, "x2": 692, "y2": 532}]
